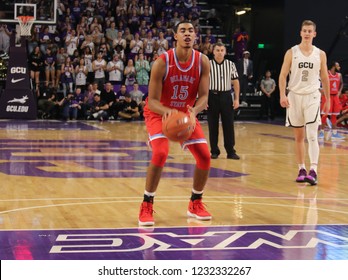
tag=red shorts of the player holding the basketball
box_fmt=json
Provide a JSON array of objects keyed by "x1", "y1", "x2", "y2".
[{"x1": 145, "y1": 113, "x2": 207, "y2": 149}]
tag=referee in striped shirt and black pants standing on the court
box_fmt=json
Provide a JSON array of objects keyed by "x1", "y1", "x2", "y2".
[{"x1": 207, "y1": 43, "x2": 239, "y2": 160}]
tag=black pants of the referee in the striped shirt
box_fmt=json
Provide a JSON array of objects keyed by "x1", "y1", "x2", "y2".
[{"x1": 207, "y1": 91, "x2": 236, "y2": 155}]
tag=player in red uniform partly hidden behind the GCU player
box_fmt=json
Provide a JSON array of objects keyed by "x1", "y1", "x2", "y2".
[{"x1": 319, "y1": 61, "x2": 344, "y2": 140}]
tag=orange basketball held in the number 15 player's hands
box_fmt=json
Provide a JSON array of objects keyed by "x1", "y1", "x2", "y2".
[{"x1": 162, "y1": 111, "x2": 193, "y2": 142}]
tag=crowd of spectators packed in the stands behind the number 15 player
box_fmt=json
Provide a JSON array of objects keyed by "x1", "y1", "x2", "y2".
[{"x1": 28, "y1": 0, "x2": 224, "y2": 120}]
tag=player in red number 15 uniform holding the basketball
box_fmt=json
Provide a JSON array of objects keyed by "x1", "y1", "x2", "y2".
[{"x1": 139, "y1": 21, "x2": 211, "y2": 226}]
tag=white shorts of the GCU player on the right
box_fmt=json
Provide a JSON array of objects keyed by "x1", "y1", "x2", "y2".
[{"x1": 285, "y1": 90, "x2": 321, "y2": 127}]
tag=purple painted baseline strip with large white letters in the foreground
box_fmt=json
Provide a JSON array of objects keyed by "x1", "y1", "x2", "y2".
[{"x1": 0, "y1": 225, "x2": 348, "y2": 260}]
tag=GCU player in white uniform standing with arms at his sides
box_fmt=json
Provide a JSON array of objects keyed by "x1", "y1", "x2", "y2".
[{"x1": 279, "y1": 20, "x2": 330, "y2": 185}]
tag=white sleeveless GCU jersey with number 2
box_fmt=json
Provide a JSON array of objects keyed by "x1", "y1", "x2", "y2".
[{"x1": 288, "y1": 45, "x2": 320, "y2": 95}]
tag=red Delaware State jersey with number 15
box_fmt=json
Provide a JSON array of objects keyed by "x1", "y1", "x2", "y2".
[{"x1": 144, "y1": 49, "x2": 202, "y2": 116}]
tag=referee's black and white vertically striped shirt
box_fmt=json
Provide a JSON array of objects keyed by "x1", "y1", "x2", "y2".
[{"x1": 209, "y1": 59, "x2": 238, "y2": 91}]
